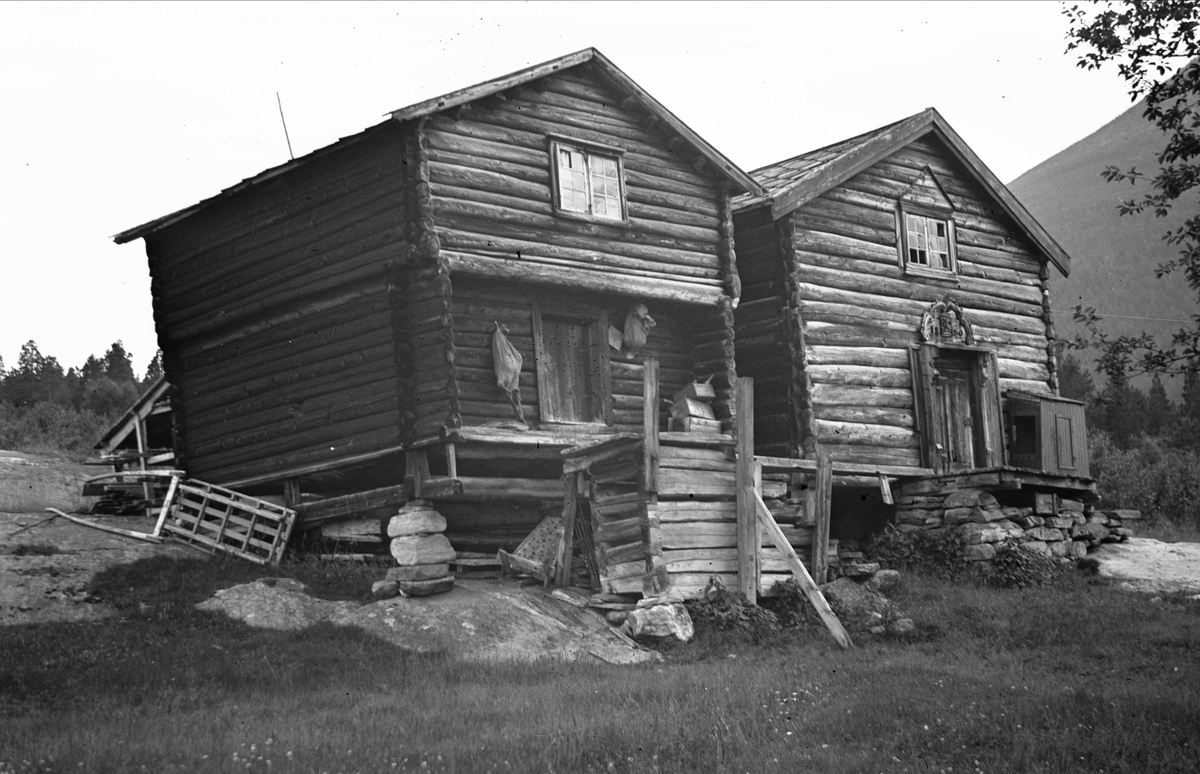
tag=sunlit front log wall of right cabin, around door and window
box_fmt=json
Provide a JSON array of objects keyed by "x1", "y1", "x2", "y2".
[{"x1": 796, "y1": 137, "x2": 1051, "y2": 466}]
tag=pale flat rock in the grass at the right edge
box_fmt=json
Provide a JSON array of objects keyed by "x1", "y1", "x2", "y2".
[{"x1": 1090, "y1": 538, "x2": 1200, "y2": 594}]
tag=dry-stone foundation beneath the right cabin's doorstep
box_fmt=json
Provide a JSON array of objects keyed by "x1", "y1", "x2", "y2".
[{"x1": 896, "y1": 481, "x2": 1141, "y2": 562}]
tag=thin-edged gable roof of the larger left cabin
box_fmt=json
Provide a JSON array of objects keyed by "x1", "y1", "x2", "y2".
[{"x1": 113, "y1": 48, "x2": 763, "y2": 245}]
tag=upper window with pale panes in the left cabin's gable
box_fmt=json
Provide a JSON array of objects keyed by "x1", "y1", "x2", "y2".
[{"x1": 551, "y1": 140, "x2": 625, "y2": 221}]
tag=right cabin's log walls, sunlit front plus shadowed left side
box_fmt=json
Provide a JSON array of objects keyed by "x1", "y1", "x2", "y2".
[{"x1": 737, "y1": 137, "x2": 1054, "y2": 467}]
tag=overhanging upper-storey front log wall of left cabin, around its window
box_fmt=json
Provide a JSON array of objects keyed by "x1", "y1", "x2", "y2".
[{"x1": 426, "y1": 62, "x2": 720, "y2": 290}]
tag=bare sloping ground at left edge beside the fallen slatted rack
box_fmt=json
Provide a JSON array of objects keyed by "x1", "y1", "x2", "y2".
[{"x1": 0, "y1": 512, "x2": 194, "y2": 626}]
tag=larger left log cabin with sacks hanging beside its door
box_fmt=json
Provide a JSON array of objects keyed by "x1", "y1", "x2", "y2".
[{"x1": 114, "y1": 48, "x2": 762, "y2": 564}]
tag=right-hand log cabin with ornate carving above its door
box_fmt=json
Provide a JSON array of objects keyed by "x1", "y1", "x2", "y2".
[{"x1": 734, "y1": 108, "x2": 1094, "y2": 549}]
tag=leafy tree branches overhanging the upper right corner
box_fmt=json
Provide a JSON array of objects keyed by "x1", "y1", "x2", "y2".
[{"x1": 1063, "y1": 0, "x2": 1200, "y2": 374}]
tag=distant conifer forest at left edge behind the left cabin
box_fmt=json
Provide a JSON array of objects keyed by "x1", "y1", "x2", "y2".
[{"x1": 0, "y1": 341, "x2": 162, "y2": 456}]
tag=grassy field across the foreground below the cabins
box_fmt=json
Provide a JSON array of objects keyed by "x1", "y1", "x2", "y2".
[{"x1": 0, "y1": 559, "x2": 1200, "y2": 774}]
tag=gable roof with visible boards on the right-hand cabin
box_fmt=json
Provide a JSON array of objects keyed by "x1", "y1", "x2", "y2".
[{"x1": 733, "y1": 108, "x2": 1070, "y2": 275}]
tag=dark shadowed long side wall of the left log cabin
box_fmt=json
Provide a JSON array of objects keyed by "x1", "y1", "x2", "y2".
[{"x1": 146, "y1": 124, "x2": 408, "y2": 482}]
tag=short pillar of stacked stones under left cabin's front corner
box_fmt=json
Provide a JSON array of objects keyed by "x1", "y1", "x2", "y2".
[{"x1": 371, "y1": 500, "x2": 456, "y2": 599}]
